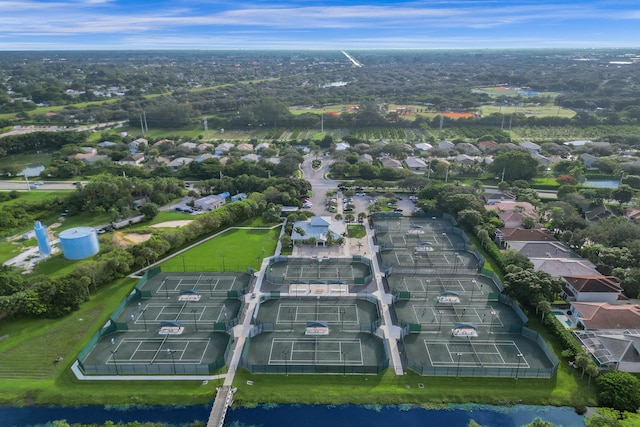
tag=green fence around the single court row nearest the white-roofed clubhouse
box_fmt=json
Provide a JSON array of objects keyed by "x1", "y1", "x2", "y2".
[{"x1": 264, "y1": 255, "x2": 373, "y2": 285}]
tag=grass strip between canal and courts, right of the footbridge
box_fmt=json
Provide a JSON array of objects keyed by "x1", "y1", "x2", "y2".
[{"x1": 233, "y1": 369, "x2": 596, "y2": 407}]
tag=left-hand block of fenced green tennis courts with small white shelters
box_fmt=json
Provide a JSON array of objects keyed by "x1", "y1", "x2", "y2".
[{"x1": 79, "y1": 273, "x2": 242, "y2": 375}]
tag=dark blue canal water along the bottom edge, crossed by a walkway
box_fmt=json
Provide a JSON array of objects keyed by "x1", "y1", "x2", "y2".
[{"x1": 0, "y1": 404, "x2": 584, "y2": 427}]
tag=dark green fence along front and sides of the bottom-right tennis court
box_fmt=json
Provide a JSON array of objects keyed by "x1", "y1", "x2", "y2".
[{"x1": 398, "y1": 326, "x2": 560, "y2": 379}]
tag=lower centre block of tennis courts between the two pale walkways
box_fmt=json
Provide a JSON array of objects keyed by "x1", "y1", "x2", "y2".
[{"x1": 244, "y1": 298, "x2": 387, "y2": 373}]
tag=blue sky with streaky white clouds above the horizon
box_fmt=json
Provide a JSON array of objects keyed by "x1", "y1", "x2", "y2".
[{"x1": 0, "y1": 0, "x2": 640, "y2": 50}]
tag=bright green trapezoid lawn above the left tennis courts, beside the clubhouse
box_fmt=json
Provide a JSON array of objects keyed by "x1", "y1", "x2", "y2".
[{"x1": 160, "y1": 228, "x2": 280, "y2": 272}]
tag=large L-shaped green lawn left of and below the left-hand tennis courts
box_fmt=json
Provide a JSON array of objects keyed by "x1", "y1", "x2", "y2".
[{"x1": 0, "y1": 279, "x2": 216, "y2": 406}]
